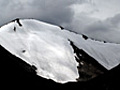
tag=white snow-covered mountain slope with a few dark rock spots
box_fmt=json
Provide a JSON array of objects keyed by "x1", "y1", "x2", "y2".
[{"x1": 0, "y1": 19, "x2": 120, "y2": 83}]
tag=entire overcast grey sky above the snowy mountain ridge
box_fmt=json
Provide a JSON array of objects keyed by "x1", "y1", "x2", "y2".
[{"x1": 0, "y1": 0, "x2": 120, "y2": 42}]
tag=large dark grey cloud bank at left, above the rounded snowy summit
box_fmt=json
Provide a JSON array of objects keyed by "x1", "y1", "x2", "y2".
[{"x1": 0, "y1": 0, "x2": 88, "y2": 25}]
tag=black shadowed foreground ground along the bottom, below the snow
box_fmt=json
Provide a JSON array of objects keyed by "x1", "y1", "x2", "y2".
[{"x1": 0, "y1": 46, "x2": 120, "y2": 90}]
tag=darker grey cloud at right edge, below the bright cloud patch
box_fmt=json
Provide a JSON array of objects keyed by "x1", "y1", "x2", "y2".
[{"x1": 85, "y1": 14, "x2": 120, "y2": 33}]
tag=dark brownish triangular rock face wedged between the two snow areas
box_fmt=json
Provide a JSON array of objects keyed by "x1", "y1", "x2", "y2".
[{"x1": 70, "y1": 41, "x2": 107, "y2": 81}]
